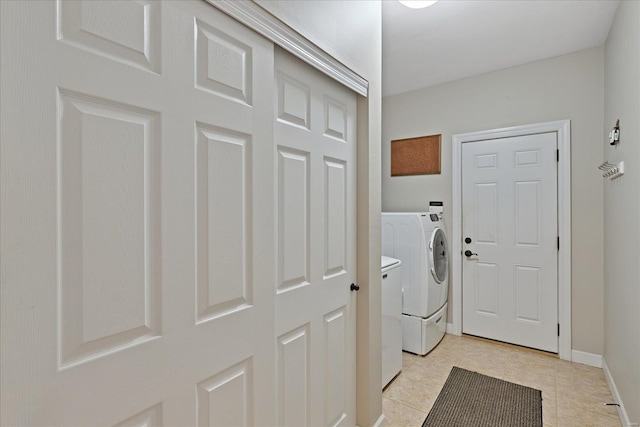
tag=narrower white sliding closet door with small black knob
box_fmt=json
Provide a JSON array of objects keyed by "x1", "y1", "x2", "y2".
[{"x1": 274, "y1": 49, "x2": 356, "y2": 426}]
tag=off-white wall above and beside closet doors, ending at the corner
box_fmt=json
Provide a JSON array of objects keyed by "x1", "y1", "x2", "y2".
[{"x1": 256, "y1": 0, "x2": 382, "y2": 426}]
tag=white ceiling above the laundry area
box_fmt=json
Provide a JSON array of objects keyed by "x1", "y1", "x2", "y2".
[{"x1": 382, "y1": 0, "x2": 618, "y2": 96}]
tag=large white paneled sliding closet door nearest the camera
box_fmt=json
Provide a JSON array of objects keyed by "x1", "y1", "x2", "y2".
[{"x1": 0, "y1": 0, "x2": 280, "y2": 426}]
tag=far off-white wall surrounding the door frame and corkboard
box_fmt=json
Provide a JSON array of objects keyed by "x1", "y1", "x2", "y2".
[{"x1": 382, "y1": 48, "x2": 604, "y2": 354}]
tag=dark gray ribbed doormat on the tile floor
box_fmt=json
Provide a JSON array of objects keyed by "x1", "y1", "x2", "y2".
[{"x1": 422, "y1": 366, "x2": 542, "y2": 427}]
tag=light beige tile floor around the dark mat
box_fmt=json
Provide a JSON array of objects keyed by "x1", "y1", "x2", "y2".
[{"x1": 382, "y1": 334, "x2": 621, "y2": 427}]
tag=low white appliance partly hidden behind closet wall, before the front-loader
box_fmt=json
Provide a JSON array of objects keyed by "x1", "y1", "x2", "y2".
[{"x1": 381, "y1": 256, "x2": 402, "y2": 388}]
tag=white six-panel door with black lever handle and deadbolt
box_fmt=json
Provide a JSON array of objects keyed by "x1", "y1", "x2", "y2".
[{"x1": 462, "y1": 132, "x2": 558, "y2": 353}]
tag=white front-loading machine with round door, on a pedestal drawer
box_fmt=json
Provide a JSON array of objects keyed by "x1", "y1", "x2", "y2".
[{"x1": 382, "y1": 212, "x2": 449, "y2": 355}]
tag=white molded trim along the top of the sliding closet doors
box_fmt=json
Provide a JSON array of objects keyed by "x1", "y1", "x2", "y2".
[{"x1": 206, "y1": 0, "x2": 369, "y2": 98}]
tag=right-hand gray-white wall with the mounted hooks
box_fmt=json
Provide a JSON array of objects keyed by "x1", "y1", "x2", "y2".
[{"x1": 603, "y1": 1, "x2": 640, "y2": 423}]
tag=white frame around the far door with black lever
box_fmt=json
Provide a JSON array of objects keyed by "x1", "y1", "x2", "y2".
[{"x1": 450, "y1": 120, "x2": 571, "y2": 361}]
